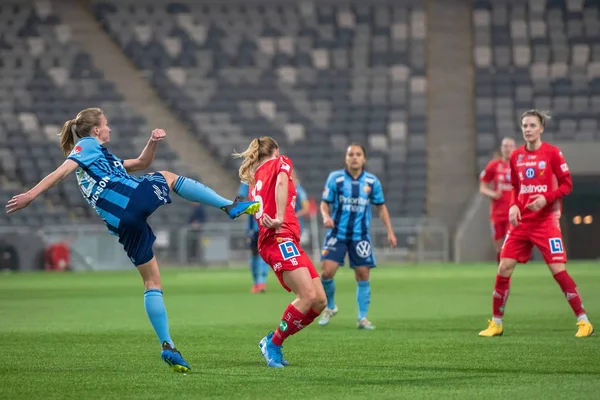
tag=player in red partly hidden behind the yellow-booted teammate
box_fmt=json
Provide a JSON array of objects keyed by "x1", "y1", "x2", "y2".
[{"x1": 479, "y1": 137, "x2": 515, "y2": 262}]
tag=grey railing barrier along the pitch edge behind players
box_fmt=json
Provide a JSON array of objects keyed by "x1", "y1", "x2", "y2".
[{"x1": 0, "y1": 216, "x2": 450, "y2": 271}]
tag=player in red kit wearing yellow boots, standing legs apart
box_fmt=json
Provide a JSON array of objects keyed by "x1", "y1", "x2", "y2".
[{"x1": 479, "y1": 110, "x2": 594, "y2": 337}]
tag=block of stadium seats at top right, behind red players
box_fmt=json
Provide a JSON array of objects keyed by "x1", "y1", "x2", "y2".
[{"x1": 473, "y1": 0, "x2": 600, "y2": 170}]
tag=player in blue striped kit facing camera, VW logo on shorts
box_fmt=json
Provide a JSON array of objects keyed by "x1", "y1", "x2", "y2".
[{"x1": 319, "y1": 143, "x2": 396, "y2": 329}]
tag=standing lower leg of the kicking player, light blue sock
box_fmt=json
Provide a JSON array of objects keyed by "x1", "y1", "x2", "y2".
[{"x1": 137, "y1": 257, "x2": 190, "y2": 372}]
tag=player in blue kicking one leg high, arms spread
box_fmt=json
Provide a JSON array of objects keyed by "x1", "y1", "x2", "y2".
[{"x1": 6, "y1": 108, "x2": 259, "y2": 372}]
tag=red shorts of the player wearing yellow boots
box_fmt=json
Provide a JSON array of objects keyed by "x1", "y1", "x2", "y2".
[{"x1": 500, "y1": 220, "x2": 567, "y2": 264}]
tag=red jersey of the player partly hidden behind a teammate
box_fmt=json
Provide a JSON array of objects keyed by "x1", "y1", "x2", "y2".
[{"x1": 479, "y1": 160, "x2": 512, "y2": 221}]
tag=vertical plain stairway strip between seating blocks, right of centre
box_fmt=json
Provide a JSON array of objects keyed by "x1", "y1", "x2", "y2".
[{"x1": 427, "y1": 0, "x2": 477, "y2": 238}]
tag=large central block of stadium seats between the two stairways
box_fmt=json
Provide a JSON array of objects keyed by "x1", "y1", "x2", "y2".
[{"x1": 94, "y1": 0, "x2": 427, "y2": 216}]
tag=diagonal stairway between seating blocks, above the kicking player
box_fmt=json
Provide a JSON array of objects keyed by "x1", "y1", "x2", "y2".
[{"x1": 55, "y1": 0, "x2": 239, "y2": 197}]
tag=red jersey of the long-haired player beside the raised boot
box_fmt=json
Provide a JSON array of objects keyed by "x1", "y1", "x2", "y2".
[{"x1": 250, "y1": 156, "x2": 300, "y2": 248}]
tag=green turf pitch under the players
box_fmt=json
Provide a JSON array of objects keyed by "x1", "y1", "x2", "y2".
[{"x1": 0, "y1": 263, "x2": 600, "y2": 399}]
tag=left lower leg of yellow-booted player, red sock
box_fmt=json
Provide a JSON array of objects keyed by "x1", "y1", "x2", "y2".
[{"x1": 479, "y1": 258, "x2": 517, "y2": 337}]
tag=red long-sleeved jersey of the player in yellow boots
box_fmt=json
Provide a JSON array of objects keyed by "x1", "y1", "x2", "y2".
[{"x1": 510, "y1": 143, "x2": 573, "y2": 222}]
